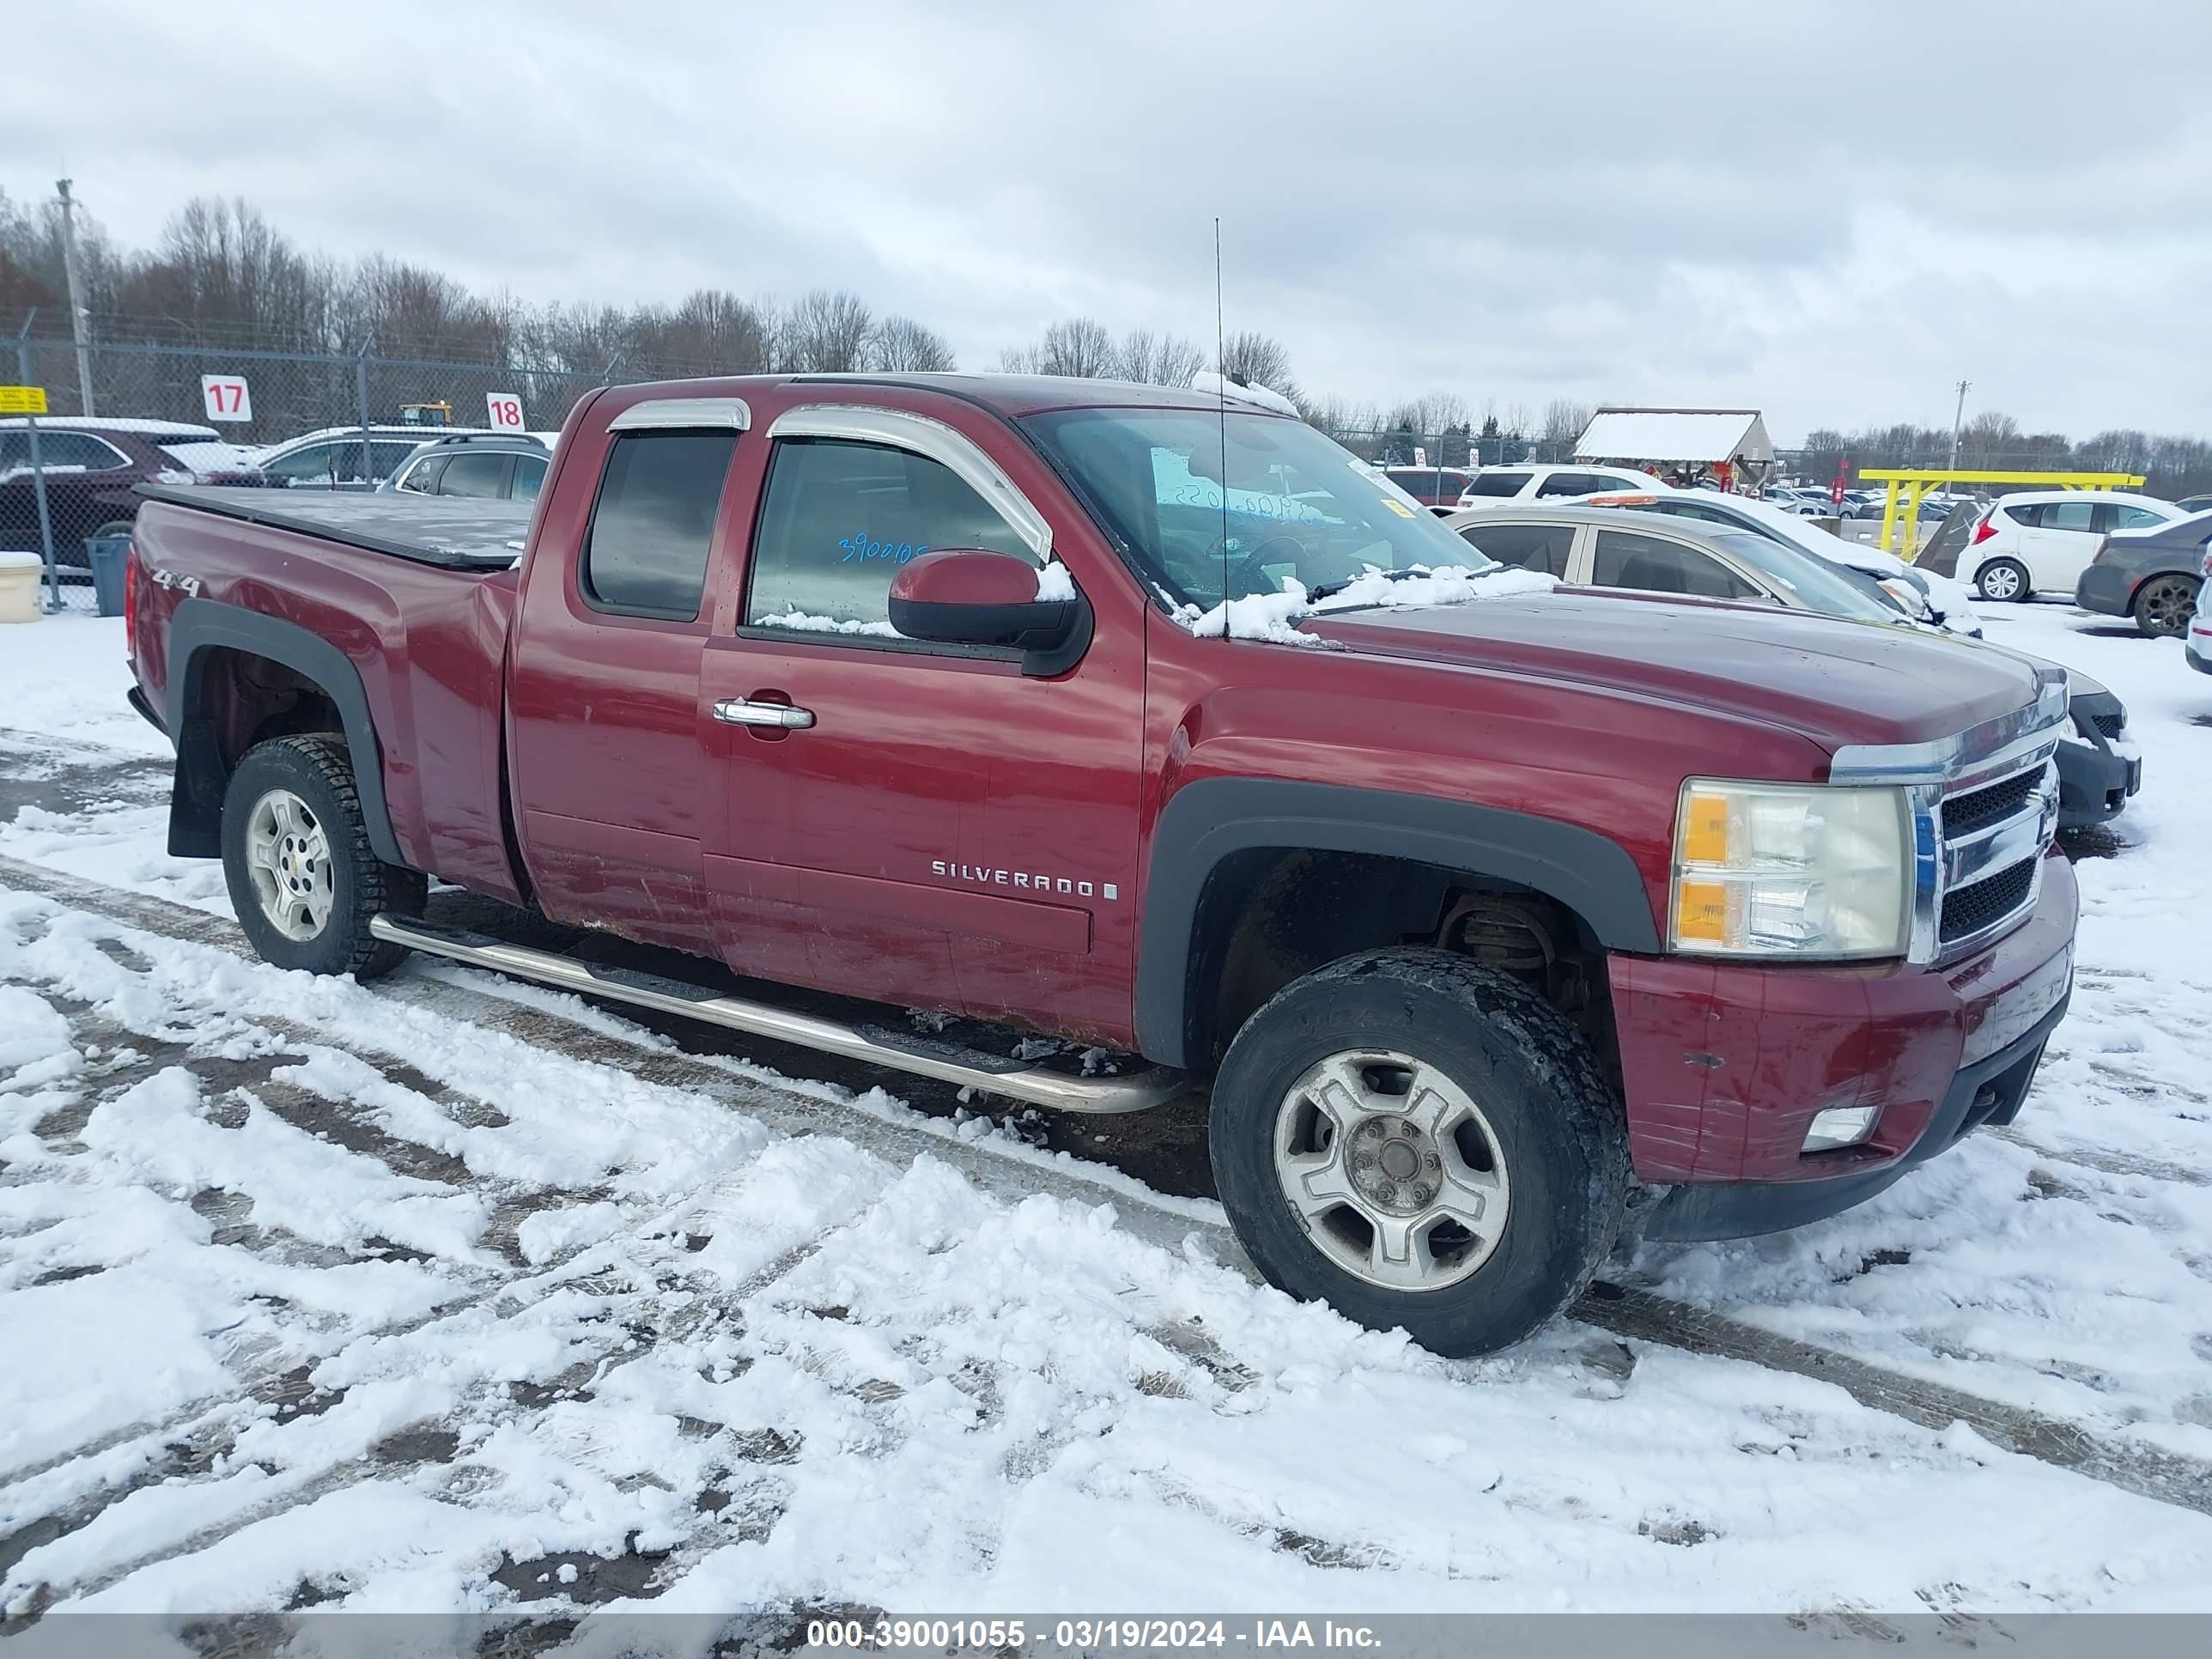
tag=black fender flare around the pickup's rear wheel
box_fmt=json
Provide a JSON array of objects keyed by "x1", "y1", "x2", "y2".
[{"x1": 168, "y1": 598, "x2": 407, "y2": 865}]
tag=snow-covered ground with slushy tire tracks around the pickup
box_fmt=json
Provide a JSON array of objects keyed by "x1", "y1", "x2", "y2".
[{"x1": 0, "y1": 606, "x2": 2212, "y2": 1620}]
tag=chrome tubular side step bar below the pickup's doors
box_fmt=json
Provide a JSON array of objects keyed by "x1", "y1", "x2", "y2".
[{"x1": 369, "y1": 915, "x2": 1190, "y2": 1113}]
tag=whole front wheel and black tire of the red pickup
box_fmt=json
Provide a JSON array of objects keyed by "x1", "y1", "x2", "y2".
[{"x1": 1210, "y1": 949, "x2": 1628, "y2": 1356}]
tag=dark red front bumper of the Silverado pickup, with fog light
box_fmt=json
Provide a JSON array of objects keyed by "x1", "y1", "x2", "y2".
[{"x1": 1608, "y1": 852, "x2": 2075, "y2": 1239}]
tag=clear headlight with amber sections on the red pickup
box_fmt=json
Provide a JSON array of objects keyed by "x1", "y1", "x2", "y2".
[{"x1": 1668, "y1": 779, "x2": 1913, "y2": 957}]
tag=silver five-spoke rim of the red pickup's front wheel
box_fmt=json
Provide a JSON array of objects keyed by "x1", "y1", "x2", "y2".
[{"x1": 1274, "y1": 1048, "x2": 1509, "y2": 1290}]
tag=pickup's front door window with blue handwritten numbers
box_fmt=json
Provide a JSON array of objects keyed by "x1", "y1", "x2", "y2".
[{"x1": 745, "y1": 438, "x2": 1037, "y2": 635}]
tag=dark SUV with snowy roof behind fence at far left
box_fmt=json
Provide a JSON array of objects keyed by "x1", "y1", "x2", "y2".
[{"x1": 0, "y1": 416, "x2": 261, "y2": 566}]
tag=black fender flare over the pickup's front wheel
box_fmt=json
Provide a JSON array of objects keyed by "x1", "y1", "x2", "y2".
[{"x1": 1134, "y1": 779, "x2": 1662, "y2": 1066}]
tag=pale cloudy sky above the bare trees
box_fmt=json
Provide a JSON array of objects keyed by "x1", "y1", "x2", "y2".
[{"x1": 0, "y1": 0, "x2": 2212, "y2": 442}]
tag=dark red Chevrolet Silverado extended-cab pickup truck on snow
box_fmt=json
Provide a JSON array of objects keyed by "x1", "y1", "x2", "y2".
[{"x1": 128, "y1": 376, "x2": 2075, "y2": 1354}]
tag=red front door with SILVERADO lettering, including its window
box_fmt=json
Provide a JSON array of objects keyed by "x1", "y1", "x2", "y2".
[{"x1": 702, "y1": 410, "x2": 1144, "y2": 1033}]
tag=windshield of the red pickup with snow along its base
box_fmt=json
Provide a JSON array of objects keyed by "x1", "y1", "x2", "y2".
[{"x1": 1022, "y1": 410, "x2": 1495, "y2": 608}]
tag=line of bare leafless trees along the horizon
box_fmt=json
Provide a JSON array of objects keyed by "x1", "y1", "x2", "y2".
[{"x1": 0, "y1": 192, "x2": 2212, "y2": 495}]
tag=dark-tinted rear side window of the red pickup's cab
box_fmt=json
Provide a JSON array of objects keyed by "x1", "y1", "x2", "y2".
[{"x1": 579, "y1": 431, "x2": 737, "y2": 622}]
